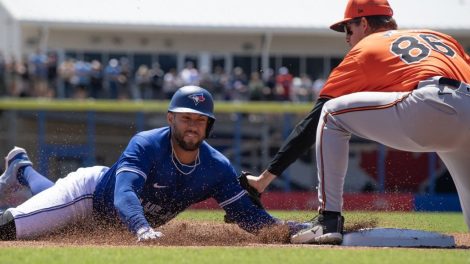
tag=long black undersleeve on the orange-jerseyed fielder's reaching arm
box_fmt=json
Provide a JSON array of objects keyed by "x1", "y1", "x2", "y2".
[{"x1": 267, "y1": 98, "x2": 328, "y2": 176}]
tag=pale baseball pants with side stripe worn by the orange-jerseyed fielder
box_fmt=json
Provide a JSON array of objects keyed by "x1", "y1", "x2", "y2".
[{"x1": 316, "y1": 77, "x2": 470, "y2": 229}]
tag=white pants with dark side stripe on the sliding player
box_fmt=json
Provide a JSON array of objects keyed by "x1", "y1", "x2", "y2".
[{"x1": 8, "y1": 166, "x2": 108, "y2": 239}]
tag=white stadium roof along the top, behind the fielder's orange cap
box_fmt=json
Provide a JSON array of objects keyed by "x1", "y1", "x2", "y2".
[{"x1": 0, "y1": 0, "x2": 470, "y2": 35}]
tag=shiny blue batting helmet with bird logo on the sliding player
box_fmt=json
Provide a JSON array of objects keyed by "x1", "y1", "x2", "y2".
[{"x1": 168, "y1": 85, "x2": 215, "y2": 137}]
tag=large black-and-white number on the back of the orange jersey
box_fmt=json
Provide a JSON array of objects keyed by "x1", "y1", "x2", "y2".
[{"x1": 390, "y1": 34, "x2": 455, "y2": 64}]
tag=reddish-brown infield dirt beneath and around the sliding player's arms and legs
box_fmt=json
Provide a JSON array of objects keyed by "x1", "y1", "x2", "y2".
[{"x1": 0, "y1": 220, "x2": 470, "y2": 249}]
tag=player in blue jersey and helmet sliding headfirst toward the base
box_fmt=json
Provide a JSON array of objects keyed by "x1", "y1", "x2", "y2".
[{"x1": 0, "y1": 86, "x2": 308, "y2": 241}]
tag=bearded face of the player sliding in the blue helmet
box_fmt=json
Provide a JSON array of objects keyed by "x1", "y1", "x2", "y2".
[{"x1": 167, "y1": 113, "x2": 208, "y2": 151}]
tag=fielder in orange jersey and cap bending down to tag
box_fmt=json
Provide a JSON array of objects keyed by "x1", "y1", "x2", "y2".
[{"x1": 249, "y1": 0, "x2": 470, "y2": 244}]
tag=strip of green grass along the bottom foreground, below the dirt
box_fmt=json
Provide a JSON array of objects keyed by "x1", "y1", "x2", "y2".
[{"x1": 0, "y1": 247, "x2": 470, "y2": 264}]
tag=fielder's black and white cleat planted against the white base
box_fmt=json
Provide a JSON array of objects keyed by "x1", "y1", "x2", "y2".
[{"x1": 290, "y1": 211, "x2": 344, "y2": 245}]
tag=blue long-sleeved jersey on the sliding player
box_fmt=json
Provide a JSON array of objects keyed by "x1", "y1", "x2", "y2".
[{"x1": 94, "y1": 127, "x2": 277, "y2": 232}]
